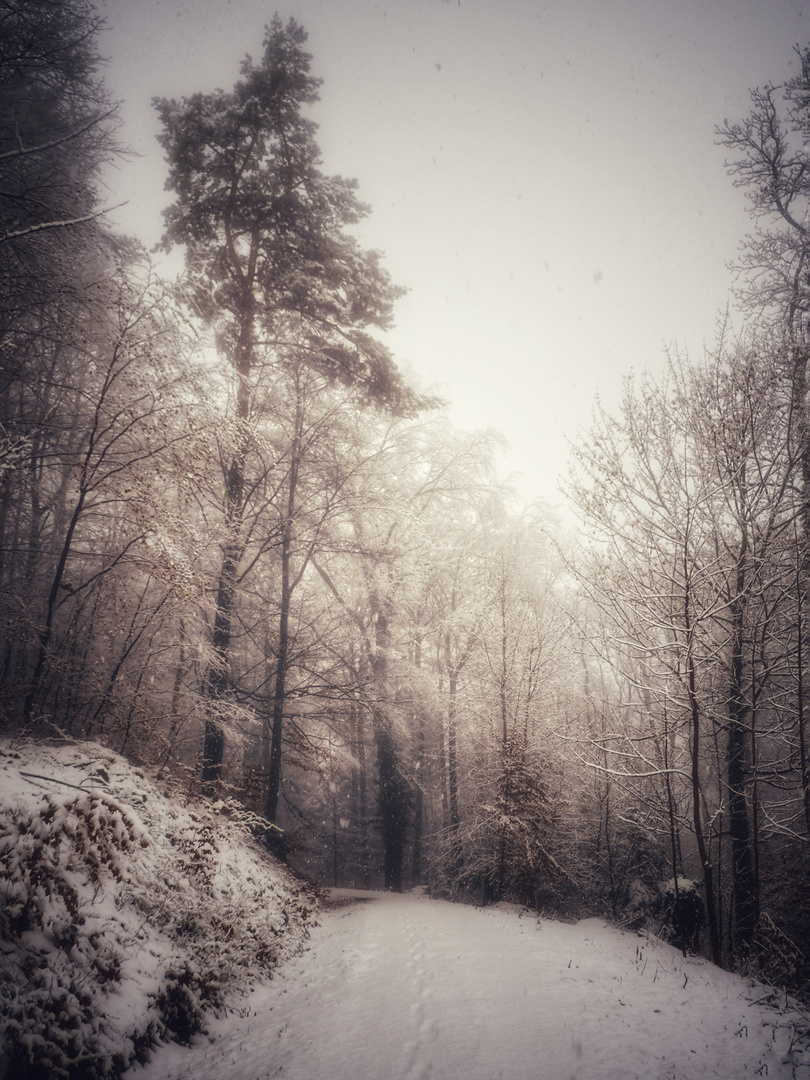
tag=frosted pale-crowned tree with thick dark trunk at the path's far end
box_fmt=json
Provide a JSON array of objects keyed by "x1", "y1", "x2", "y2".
[{"x1": 304, "y1": 418, "x2": 505, "y2": 891}]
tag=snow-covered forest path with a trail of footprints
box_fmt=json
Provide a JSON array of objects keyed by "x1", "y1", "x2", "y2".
[{"x1": 127, "y1": 894, "x2": 810, "y2": 1080}]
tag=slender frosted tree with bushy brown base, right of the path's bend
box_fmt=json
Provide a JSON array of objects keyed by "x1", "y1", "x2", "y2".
[{"x1": 443, "y1": 505, "x2": 567, "y2": 904}]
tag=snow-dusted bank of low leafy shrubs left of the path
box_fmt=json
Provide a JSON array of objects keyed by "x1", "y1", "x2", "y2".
[{"x1": 0, "y1": 741, "x2": 314, "y2": 1080}]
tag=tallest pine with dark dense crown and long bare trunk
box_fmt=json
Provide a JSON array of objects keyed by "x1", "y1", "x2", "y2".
[{"x1": 156, "y1": 16, "x2": 418, "y2": 784}]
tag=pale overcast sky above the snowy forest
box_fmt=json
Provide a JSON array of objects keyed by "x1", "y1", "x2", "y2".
[{"x1": 99, "y1": 0, "x2": 810, "y2": 502}]
